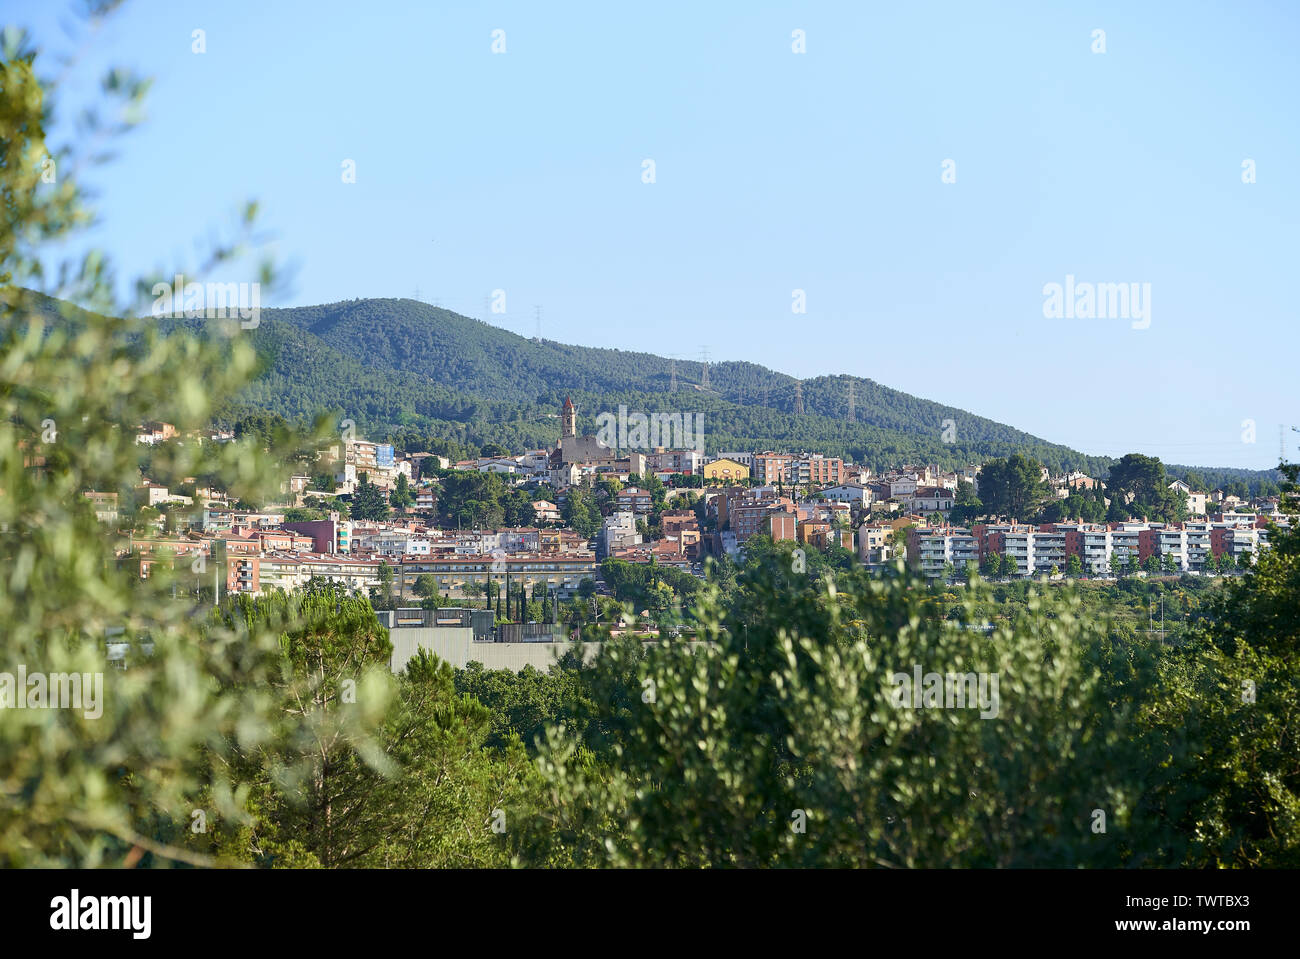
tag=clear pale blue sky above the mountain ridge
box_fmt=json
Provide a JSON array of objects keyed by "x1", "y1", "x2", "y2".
[{"x1": 5, "y1": 0, "x2": 1300, "y2": 468}]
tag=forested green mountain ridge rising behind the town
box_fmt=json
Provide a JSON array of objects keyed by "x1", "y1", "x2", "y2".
[{"x1": 17, "y1": 291, "x2": 1278, "y2": 487}]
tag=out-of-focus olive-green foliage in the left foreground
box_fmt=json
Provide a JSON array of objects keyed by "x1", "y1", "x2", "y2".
[{"x1": 0, "y1": 4, "x2": 338, "y2": 865}]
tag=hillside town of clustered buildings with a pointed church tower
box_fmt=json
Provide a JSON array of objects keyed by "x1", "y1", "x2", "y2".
[{"x1": 104, "y1": 399, "x2": 1286, "y2": 622}]
